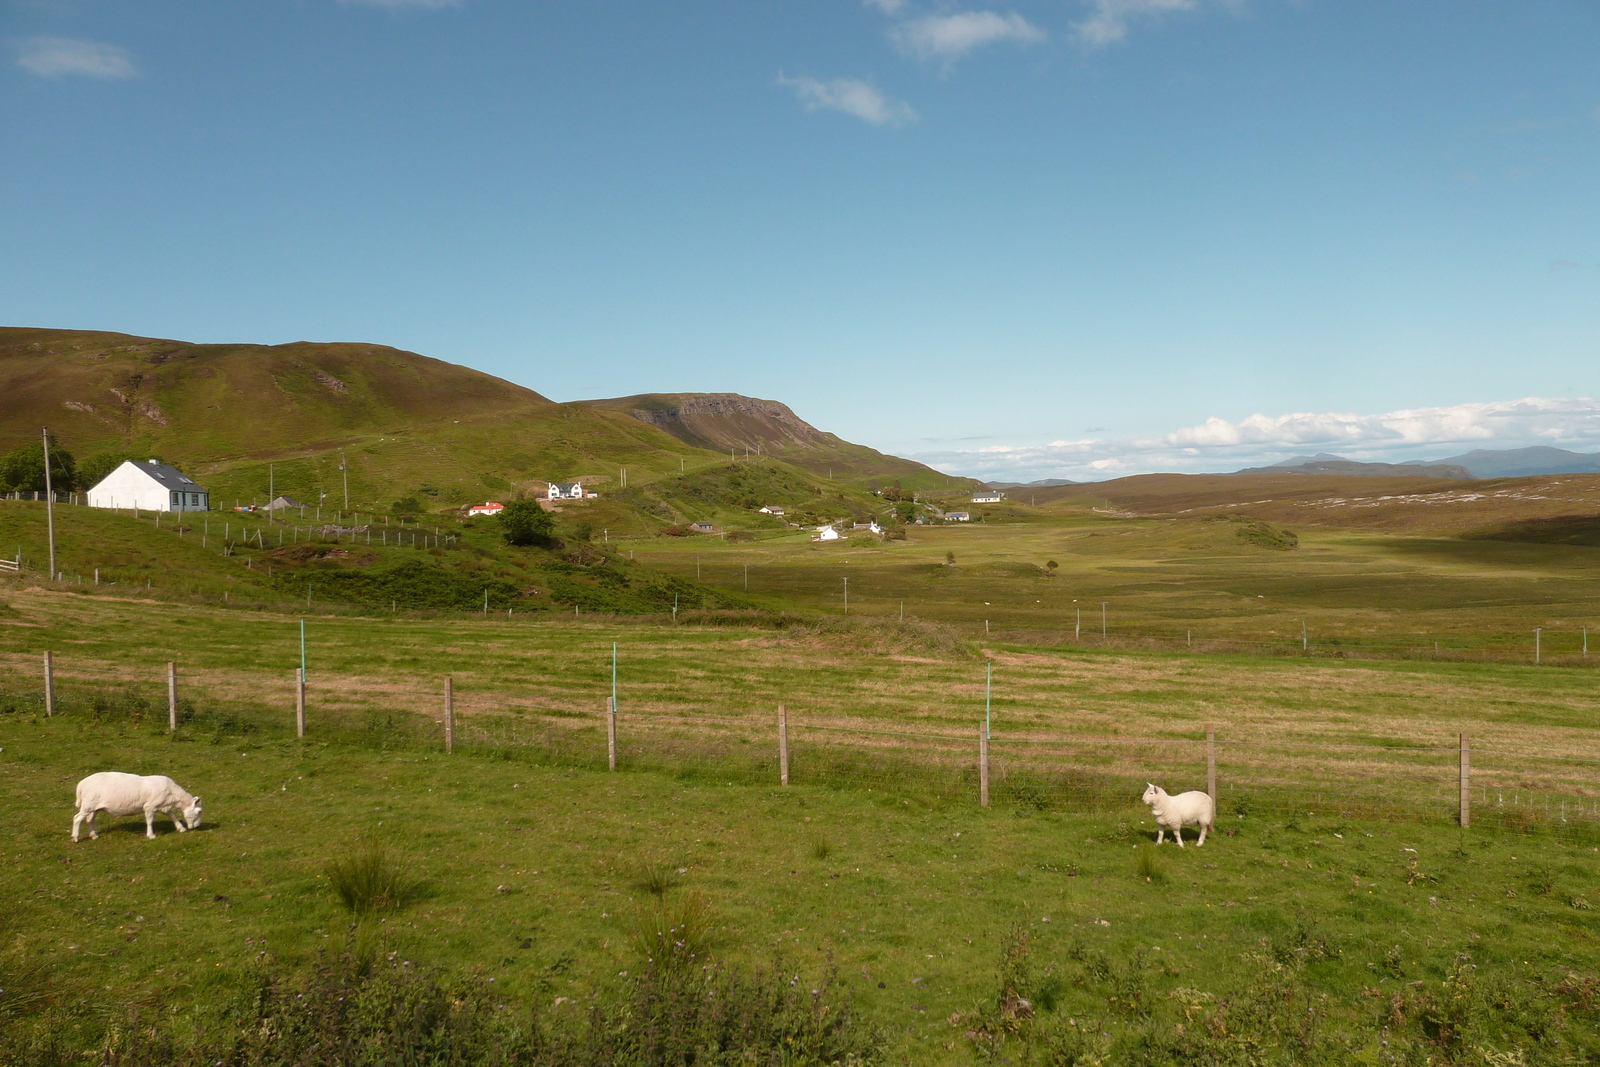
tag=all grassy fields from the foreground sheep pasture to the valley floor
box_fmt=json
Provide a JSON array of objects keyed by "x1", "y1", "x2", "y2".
[{"x1": 0, "y1": 486, "x2": 1600, "y2": 1064}]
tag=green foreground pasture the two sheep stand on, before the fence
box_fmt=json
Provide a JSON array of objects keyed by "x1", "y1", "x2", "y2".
[{"x1": 0, "y1": 703, "x2": 1600, "y2": 1064}]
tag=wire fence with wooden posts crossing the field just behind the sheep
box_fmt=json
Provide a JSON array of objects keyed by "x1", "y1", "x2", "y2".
[{"x1": 0, "y1": 656, "x2": 1600, "y2": 843}]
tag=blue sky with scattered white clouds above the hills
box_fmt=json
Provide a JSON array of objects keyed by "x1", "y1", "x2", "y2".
[{"x1": 0, "y1": 0, "x2": 1600, "y2": 482}]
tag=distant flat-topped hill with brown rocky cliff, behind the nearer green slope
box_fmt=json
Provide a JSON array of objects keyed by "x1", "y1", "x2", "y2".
[{"x1": 579, "y1": 394, "x2": 979, "y2": 490}]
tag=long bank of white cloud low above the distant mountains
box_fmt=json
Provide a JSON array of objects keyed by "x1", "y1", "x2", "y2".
[{"x1": 912, "y1": 397, "x2": 1600, "y2": 482}]
